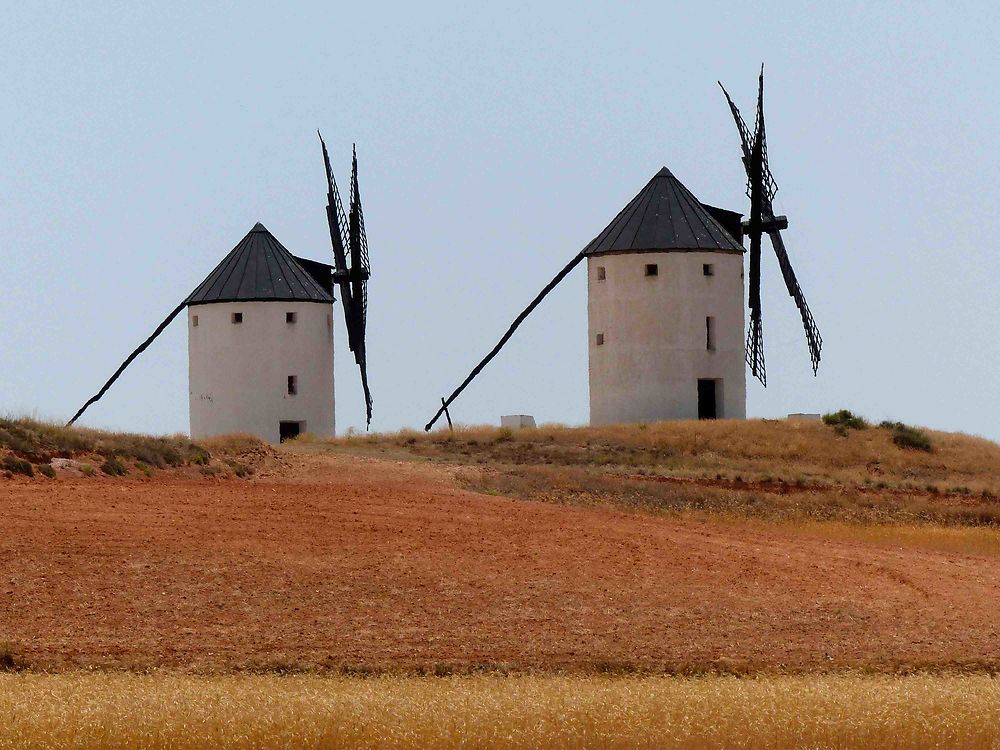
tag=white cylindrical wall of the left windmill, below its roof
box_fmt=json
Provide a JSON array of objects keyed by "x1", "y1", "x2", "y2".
[{"x1": 188, "y1": 302, "x2": 335, "y2": 443}]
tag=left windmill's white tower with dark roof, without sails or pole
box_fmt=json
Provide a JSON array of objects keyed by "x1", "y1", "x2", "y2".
[{"x1": 188, "y1": 223, "x2": 335, "y2": 443}]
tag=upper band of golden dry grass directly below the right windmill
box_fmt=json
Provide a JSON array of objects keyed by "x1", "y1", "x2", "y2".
[{"x1": 328, "y1": 420, "x2": 1000, "y2": 496}]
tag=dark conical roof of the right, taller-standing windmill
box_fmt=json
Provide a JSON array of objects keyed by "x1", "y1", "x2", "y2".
[{"x1": 583, "y1": 167, "x2": 743, "y2": 255}]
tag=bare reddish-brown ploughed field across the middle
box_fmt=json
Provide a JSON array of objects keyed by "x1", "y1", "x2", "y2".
[{"x1": 0, "y1": 455, "x2": 1000, "y2": 671}]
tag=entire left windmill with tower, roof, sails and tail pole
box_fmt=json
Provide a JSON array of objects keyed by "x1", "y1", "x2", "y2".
[{"x1": 69, "y1": 137, "x2": 372, "y2": 441}]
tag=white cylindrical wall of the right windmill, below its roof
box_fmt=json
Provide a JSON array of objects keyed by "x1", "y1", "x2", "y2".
[{"x1": 587, "y1": 252, "x2": 746, "y2": 425}]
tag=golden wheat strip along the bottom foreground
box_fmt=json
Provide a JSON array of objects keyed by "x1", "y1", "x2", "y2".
[{"x1": 0, "y1": 673, "x2": 1000, "y2": 750}]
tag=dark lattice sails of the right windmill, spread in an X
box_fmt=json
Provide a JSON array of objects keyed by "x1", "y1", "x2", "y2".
[{"x1": 719, "y1": 65, "x2": 823, "y2": 387}]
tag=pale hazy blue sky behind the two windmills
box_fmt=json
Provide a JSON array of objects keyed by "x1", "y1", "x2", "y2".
[{"x1": 0, "y1": 1, "x2": 1000, "y2": 439}]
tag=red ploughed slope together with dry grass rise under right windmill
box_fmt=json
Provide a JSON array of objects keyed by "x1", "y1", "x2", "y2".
[{"x1": 0, "y1": 421, "x2": 1000, "y2": 673}]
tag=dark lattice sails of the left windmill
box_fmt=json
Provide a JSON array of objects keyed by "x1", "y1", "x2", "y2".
[{"x1": 317, "y1": 131, "x2": 372, "y2": 427}]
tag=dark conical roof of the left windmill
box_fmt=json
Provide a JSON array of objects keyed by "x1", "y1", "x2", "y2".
[{"x1": 187, "y1": 222, "x2": 333, "y2": 305}]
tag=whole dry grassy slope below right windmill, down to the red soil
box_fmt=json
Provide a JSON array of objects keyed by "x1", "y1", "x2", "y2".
[{"x1": 314, "y1": 420, "x2": 1000, "y2": 555}]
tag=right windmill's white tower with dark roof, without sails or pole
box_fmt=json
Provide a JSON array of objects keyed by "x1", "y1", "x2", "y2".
[{"x1": 584, "y1": 167, "x2": 746, "y2": 425}]
